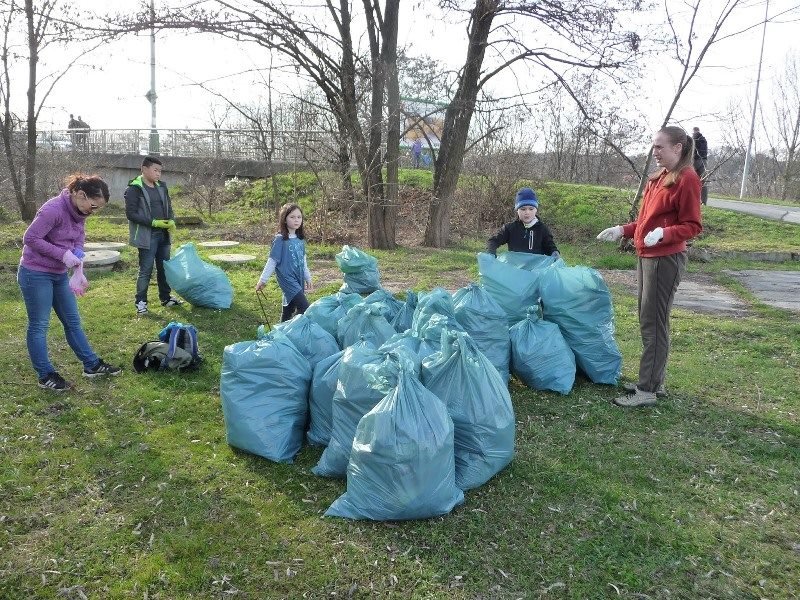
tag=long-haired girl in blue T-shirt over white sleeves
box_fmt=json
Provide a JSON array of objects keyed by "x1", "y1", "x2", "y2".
[{"x1": 256, "y1": 204, "x2": 311, "y2": 321}]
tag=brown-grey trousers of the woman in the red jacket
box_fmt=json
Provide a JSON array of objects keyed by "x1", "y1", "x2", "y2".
[{"x1": 636, "y1": 252, "x2": 686, "y2": 392}]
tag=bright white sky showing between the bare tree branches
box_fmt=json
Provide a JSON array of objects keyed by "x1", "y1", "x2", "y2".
[{"x1": 16, "y1": 0, "x2": 800, "y2": 146}]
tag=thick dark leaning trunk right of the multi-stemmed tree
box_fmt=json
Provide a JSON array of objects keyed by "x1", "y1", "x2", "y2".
[{"x1": 424, "y1": 0, "x2": 498, "y2": 248}]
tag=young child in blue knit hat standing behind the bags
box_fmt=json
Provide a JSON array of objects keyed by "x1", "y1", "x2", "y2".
[{"x1": 486, "y1": 188, "x2": 560, "y2": 258}]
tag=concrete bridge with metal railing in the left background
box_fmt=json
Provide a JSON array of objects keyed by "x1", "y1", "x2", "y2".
[{"x1": 37, "y1": 129, "x2": 337, "y2": 198}]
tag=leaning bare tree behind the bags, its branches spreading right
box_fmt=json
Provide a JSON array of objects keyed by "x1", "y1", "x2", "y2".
[{"x1": 424, "y1": 0, "x2": 638, "y2": 247}]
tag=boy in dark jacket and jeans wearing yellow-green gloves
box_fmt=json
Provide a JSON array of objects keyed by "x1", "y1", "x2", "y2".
[{"x1": 125, "y1": 156, "x2": 183, "y2": 315}]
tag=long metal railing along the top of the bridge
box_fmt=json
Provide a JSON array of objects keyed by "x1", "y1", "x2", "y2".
[{"x1": 37, "y1": 129, "x2": 335, "y2": 162}]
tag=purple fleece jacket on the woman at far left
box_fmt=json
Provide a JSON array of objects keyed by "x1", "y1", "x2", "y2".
[{"x1": 20, "y1": 188, "x2": 87, "y2": 273}]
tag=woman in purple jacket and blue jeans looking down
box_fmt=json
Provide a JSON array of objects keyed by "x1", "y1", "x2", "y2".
[{"x1": 17, "y1": 173, "x2": 122, "y2": 392}]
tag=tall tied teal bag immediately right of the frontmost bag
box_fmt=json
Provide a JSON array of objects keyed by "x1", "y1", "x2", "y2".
[{"x1": 422, "y1": 331, "x2": 515, "y2": 491}]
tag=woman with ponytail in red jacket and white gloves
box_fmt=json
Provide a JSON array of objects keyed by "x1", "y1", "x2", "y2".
[{"x1": 597, "y1": 127, "x2": 703, "y2": 407}]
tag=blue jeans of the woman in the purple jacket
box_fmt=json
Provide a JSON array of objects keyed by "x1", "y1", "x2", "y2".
[{"x1": 17, "y1": 266, "x2": 100, "y2": 379}]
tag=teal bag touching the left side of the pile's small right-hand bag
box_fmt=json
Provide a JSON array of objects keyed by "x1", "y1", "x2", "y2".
[{"x1": 453, "y1": 283, "x2": 511, "y2": 384}]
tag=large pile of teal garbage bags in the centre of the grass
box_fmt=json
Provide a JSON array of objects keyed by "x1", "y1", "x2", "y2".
[{"x1": 220, "y1": 246, "x2": 622, "y2": 521}]
